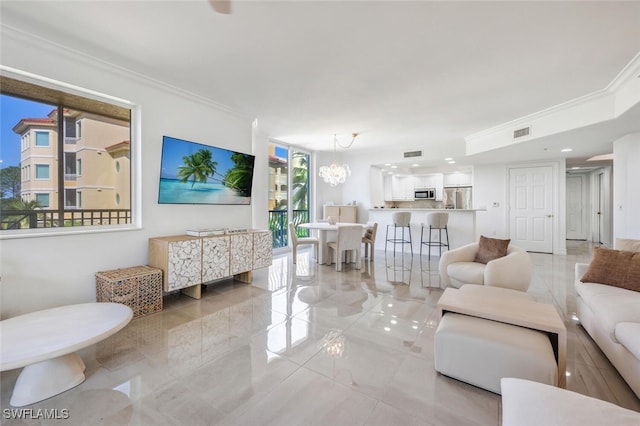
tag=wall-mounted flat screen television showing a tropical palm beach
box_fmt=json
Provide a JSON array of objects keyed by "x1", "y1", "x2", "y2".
[{"x1": 158, "y1": 136, "x2": 255, "y2": 204}]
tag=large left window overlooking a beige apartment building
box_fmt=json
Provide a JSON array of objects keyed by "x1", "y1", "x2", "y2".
[{"x1": 0, "y1": 69, "x2": 140, "y2": 238}]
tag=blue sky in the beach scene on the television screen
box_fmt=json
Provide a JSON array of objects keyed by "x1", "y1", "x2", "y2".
[{"x1": 160, "y1": 136, "x2": 249, "y2": 179}]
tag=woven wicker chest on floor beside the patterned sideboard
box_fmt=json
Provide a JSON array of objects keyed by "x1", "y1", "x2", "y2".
[{"x1": 96, "y1": 266, "x2": 162, "y2": 318}]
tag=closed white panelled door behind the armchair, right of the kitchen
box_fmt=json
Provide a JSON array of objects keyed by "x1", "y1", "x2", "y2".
[{"x1": 509, "y1": 166, "x2": 553, "y2": 253}]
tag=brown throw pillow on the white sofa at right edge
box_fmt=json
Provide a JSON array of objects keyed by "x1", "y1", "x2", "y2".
[{"x1": 580, "y1": 247, "x2": 640, "y2": 291}]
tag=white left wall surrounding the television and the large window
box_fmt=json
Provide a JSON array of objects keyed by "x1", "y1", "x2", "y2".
[{"x1": 0, "y1": 27, "x2": 258, "y2": 318}]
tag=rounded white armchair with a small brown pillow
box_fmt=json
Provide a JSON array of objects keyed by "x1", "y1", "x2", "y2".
[{"x1": 439, "y1": 243, "x2": 531, "y2": 291}]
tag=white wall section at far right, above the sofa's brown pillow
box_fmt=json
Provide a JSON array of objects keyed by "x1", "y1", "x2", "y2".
[{"x1": 613, "y1": 133, "x2": 640, "y2": 241}]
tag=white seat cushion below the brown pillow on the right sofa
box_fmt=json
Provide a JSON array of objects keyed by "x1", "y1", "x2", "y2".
[{"x1": 576, "y1": 282, "x2": 640, "y2": 343}]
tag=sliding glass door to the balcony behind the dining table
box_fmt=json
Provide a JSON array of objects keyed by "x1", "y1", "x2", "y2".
[{"x1": 269, "y1": 143, "x2": 311, "y2": 248}]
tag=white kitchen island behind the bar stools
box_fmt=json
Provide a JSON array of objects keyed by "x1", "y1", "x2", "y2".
[{"x1": 368, "y1": 208, "x2": 486, "y2": 255}]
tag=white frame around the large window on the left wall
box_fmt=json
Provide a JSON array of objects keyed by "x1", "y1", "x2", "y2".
[{"x1": 0, "y1": 65, "x2": 142, "y2": 240}]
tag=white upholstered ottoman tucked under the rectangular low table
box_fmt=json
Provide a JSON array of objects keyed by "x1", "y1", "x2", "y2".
[{"x1": 434, "y1": 312, "x2": 558, "y2": 394}]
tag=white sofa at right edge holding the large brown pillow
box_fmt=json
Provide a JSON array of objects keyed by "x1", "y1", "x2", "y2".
[{"x1": 575, "y1": 240, "x2": 640, "y2": 397}]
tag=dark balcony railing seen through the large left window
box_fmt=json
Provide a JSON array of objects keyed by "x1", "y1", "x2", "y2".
[{"x1": 0, "y1": 208, "x2": 131, "y2": 230}]
